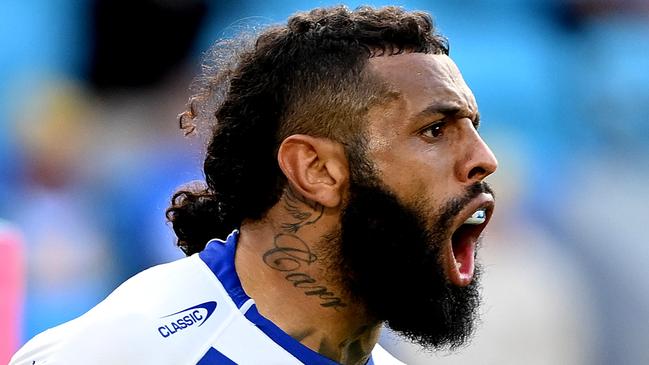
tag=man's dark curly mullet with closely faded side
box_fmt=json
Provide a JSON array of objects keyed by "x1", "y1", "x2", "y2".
[{"x1": 167, "y1": 6, "x2": 448, "y2": 255}]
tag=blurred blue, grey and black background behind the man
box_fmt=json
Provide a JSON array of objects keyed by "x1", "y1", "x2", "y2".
[{"x1": 0, "y1": 0, "x2": 649, "y2": 364}]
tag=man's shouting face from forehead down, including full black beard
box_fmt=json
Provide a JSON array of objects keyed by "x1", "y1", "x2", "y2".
[{"x1": 340, "y1": 53, "x2": 497, "y2": 348}]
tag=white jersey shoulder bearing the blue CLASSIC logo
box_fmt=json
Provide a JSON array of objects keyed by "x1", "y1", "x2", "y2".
[{"x1": 10, "y1": 255, "x2": 233, "y2": 365}]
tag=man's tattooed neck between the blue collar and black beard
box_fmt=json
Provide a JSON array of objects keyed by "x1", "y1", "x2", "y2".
[{"x1": 235, "y1": 193, "x2": 381, "y2": 365}]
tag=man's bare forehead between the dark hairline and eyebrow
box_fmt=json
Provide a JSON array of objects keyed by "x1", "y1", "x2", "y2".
[{"x1": 368, "y1": 53, "x2": 477, "y2": 115}]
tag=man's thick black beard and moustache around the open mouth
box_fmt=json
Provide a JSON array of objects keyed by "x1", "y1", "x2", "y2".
[{"x1": 329, "y1": 145, "x2": 491, "y2": 350}]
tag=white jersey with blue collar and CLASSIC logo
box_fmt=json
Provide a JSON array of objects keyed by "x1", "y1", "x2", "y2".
[{"x1": 10, "y1": 231, "x2": 402, "y2": 365}]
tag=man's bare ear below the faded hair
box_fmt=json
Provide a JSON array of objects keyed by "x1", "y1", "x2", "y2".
[{"x1": 277, "y1": 134, "x2": 349, "y2": 208}]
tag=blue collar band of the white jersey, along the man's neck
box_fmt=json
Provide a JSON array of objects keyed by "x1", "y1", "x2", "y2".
[{"x1": 198, "y1": 230, "x2": 338, "y2": 365}]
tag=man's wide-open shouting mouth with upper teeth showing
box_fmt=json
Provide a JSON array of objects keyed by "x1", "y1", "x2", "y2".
[{"x1": 446, "y1": 194, "x2": 494, "y2": 286}]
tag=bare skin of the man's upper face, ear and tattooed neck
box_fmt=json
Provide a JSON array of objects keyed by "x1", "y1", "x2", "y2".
[{"x1": 235, "y1": 53, "x2": 497, "y2": 365}]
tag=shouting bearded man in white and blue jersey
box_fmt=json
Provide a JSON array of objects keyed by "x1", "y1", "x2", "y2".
[{"x1": 13, "y1": 7, "x2": 497, "y2": 365}]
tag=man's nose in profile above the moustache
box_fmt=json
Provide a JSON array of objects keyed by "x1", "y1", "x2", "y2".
[{"x1": 455, "y1": 129, "x2": 498, "y2": 184}]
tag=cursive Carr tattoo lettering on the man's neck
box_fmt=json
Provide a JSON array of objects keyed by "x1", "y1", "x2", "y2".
[{"x1": 263, "y1": 233, "x2": 347, "y2": 310}]
